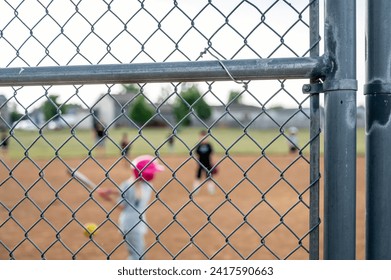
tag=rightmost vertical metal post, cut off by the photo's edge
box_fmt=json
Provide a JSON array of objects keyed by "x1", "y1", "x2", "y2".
[{"x1": 365, "y1": 0, "x2": 391, "y2": 259}]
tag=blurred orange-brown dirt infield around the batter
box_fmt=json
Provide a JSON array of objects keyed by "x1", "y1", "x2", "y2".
[{"x1": 0, "y1": 156, "x2": 365, "y2": 259}]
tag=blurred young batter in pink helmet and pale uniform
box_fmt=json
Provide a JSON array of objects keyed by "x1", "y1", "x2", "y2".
[{"x1": 98, "y1": 155, "x2": 164, "y2": 260}]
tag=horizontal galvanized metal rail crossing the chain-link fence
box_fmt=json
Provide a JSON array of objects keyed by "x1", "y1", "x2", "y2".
[{"x1": 0, "y1": 57, "x2": 328, "y2": 86}]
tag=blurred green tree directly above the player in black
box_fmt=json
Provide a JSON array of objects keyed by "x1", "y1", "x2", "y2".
[{"x1": 174, "y1": 86, "x2": 212, "y2": 126}]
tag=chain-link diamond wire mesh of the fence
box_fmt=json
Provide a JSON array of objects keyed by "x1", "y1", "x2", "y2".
[{"x1": 0, "y1": 0, "x2": 319, "y2": 259}]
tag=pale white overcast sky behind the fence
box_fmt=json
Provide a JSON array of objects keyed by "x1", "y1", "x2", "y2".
[{"x1": 0, "y1": 0, "x2": 365, "y2": 111}]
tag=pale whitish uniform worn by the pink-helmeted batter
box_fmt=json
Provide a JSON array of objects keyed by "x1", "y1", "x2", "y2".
[{"x1": 118, "y1": 178, "x2": 152, "y2": 260}]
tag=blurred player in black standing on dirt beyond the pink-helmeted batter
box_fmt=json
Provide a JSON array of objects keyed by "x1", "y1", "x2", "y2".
[{"x1": 193, "y1": 131, "x2": 215, "y2": 194}]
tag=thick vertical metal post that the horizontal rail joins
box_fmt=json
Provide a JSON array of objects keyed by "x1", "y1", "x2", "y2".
[{"x1": 323, "y1": 0, "x2": 357, "y2": 259}]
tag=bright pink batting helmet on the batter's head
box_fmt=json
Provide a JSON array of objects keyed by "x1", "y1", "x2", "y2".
[{"x1": 132, "y1": 155, "x2": 164, "y2": 182}]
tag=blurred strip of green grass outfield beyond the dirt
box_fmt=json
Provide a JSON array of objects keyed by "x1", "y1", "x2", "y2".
[{"x1": 3, "y1": 128, "x2": 365, "y2": 159}]
